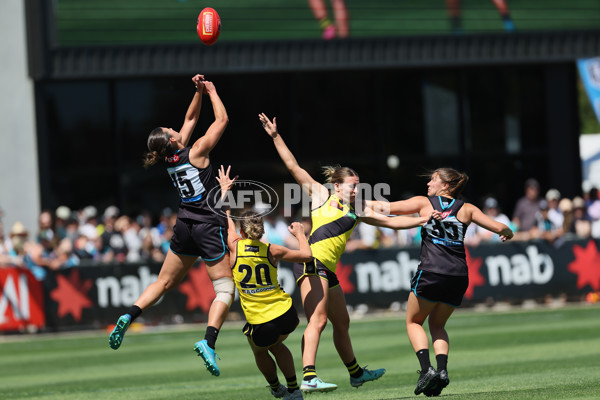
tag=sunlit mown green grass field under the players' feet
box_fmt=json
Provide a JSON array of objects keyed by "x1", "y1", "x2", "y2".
[{"x1": 0, "y1": 306, "x2": 600, "y2": 400}]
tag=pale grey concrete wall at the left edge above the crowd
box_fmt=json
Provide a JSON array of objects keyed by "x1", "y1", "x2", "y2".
[{"x1": 0, "y1": 0, "x2": 40, "y2": 235}]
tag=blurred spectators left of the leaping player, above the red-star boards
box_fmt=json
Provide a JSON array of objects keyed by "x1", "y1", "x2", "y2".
[{"x1": 0, "y1": 206, "x2": 177, "y2": 280}]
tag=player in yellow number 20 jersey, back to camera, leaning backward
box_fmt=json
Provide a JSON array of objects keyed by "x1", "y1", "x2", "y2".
[{"x1": 217, "y1": 166, "x2": 312, "y2": 400}]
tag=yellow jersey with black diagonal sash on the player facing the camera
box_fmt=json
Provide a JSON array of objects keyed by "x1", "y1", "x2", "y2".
[{"x1": 308, "y1": 195, "x2": 358, "y2": 272}]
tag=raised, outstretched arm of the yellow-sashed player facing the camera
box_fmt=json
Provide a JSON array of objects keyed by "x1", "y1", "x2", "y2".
[{"x1": 258, "y1": 113, "x2": 329, "y2": 205}]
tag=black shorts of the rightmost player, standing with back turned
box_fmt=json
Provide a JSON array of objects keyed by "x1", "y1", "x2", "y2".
[{"x1": 410, "y1": 269, "x2": 469, "y2": 307}]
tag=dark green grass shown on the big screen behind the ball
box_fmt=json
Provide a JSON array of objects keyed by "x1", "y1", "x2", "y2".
[{"x1": 55, "y1": 0, "x2": 600, "y2": 46}]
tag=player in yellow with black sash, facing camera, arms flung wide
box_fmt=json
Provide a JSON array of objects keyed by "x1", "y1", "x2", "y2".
[{"x1": 259, "y1": 113, "x2": 429, "y2": 392}]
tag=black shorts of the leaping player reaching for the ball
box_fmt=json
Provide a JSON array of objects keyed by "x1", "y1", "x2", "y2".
[{"x1": 171, "y1": 218, "x2": 229, "y2": 261}]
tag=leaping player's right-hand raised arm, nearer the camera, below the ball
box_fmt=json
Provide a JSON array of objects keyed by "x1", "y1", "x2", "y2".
[{"x1": 190, "y1": 81, "x2": 229, "y2": 168}]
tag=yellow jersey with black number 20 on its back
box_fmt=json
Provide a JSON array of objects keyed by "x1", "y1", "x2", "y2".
[{"x1": 233, "y1": 239, "x2": 292, "y2": 325}]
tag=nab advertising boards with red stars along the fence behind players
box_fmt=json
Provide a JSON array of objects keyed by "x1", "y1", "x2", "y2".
[{"x1": 0, "y1": 239, "x2": 600, "y2": 331}]
